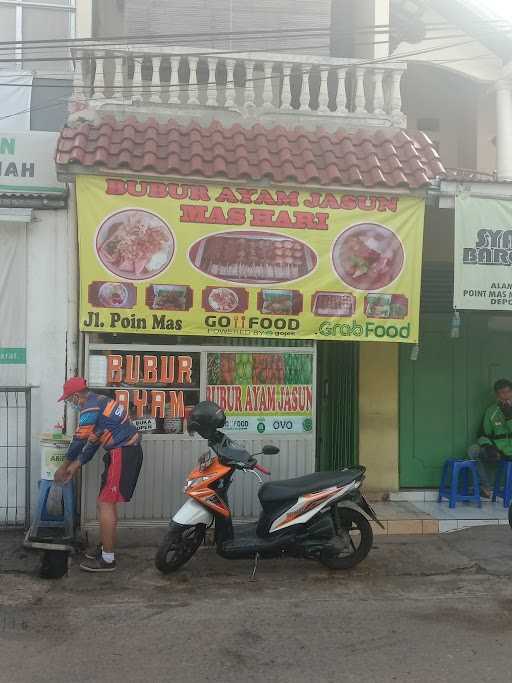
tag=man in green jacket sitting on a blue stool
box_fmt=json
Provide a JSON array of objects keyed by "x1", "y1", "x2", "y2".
[{"x1": 468, "y1": 379, "x2": 512, "y2": 498}]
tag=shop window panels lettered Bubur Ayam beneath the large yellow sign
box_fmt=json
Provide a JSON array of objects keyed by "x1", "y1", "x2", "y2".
[{"x1": 87, "y1": 345, "x2": 315, "y2": 434}]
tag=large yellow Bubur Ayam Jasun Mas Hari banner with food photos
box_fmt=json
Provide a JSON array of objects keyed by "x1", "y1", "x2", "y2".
[{"x1": 77, "y1": 177, "x2": 424, "y2": 342}]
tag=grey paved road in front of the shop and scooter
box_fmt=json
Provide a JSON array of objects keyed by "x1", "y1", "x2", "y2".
[{"x1": 0, "y1": 527, "x2": 512, "y2": 683}]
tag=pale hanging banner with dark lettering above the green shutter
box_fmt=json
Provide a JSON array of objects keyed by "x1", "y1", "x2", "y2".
[{"x1": 453, "y1": 195, "x2": 512, "y2": 311}]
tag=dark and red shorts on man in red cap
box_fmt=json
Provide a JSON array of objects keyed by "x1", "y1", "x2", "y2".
[{"x1": 98, "y1": 444, "x2": 143, "y2": 503}]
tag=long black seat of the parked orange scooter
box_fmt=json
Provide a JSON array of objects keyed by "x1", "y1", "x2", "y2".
[{"x1": 258, "y1": 467, "x2": 364, "y2": 507}]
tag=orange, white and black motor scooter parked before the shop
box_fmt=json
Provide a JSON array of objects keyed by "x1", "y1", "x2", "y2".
[{"x1": 155, "y1": 430, "x2": 382, "y2": 574}]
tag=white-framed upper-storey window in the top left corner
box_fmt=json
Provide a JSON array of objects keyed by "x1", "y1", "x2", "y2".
[{"x1": 0, "y1": 0, "x2": 76, "y2": 74}]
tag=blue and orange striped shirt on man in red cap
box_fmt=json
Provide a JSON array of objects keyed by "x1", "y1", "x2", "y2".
[{"x1": 66, "y1": 393, "x2": 141, "y2": 465}]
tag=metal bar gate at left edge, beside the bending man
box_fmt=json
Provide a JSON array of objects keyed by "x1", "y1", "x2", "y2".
[{"x1": 0, "y1": 387, "x2": 30, "y2": 528}]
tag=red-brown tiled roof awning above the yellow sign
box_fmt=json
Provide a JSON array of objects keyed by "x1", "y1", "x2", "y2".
[{"x1": 56, "y1": 117, "x2": 444, "y2": 189}]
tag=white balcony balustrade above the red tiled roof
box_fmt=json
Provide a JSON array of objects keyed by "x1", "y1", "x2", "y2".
[{"x1": 73, "y1": 46, "x2": 406, "y2": 126}]
